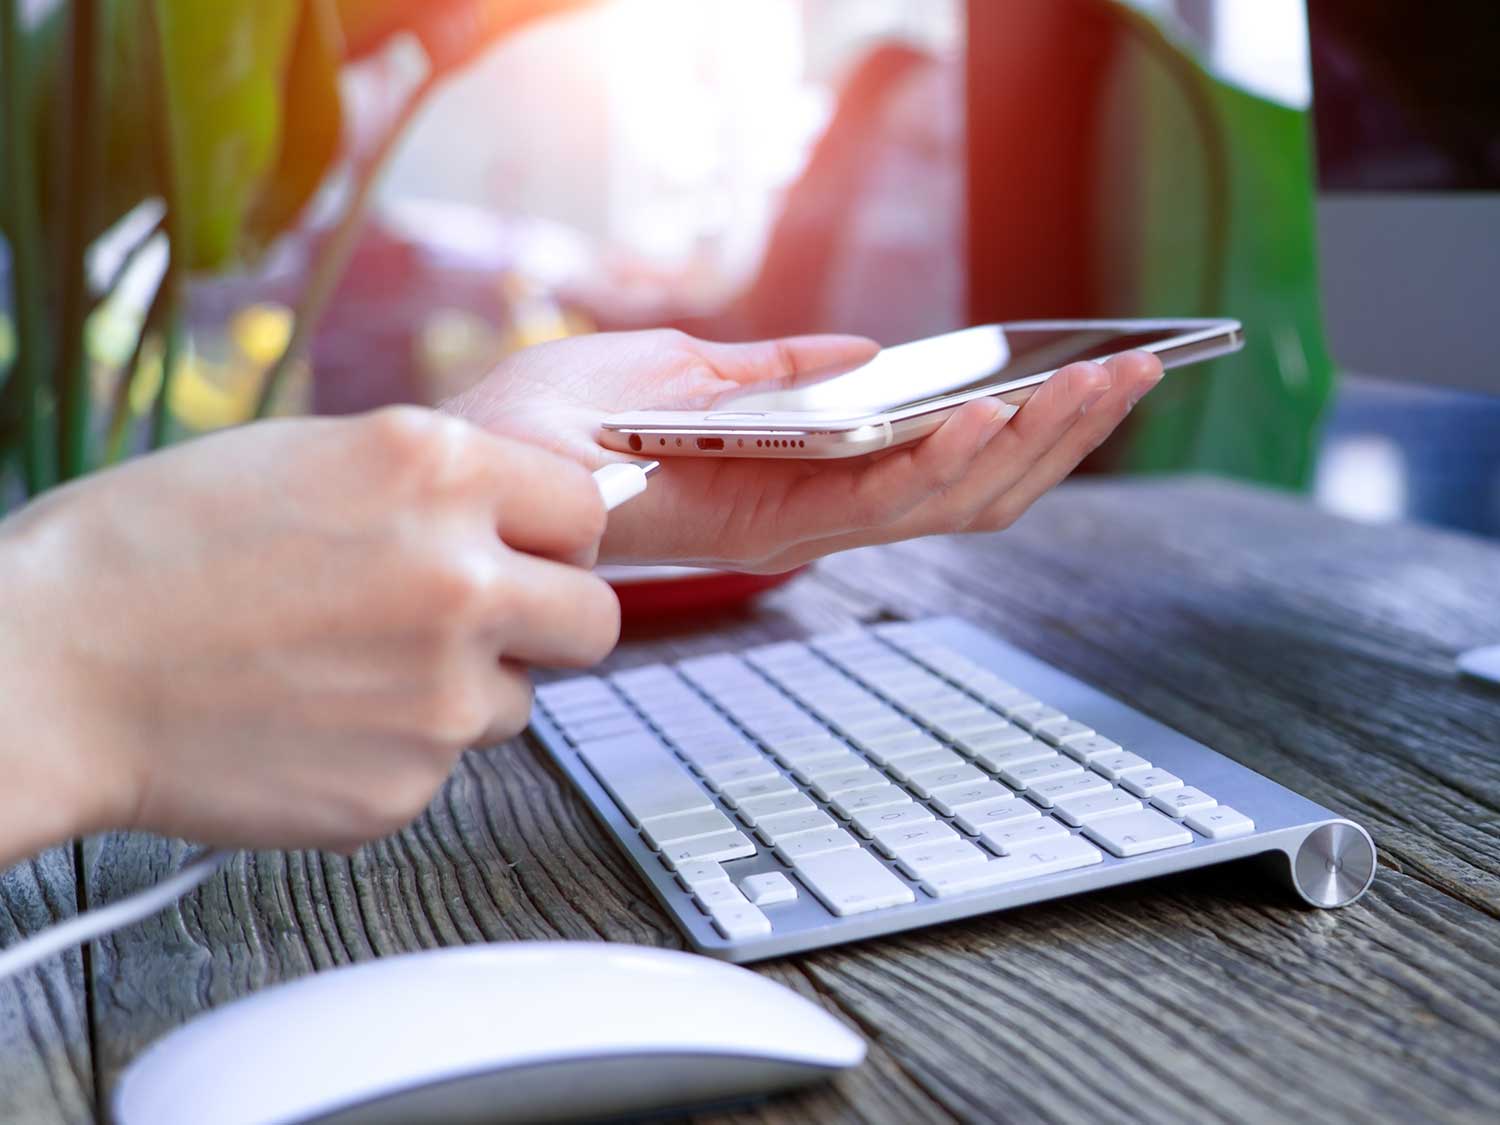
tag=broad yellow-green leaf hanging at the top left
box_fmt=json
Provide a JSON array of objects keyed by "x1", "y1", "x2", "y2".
[{"x1": 156, "y1": 0, "x2": 300, "y2": 270}]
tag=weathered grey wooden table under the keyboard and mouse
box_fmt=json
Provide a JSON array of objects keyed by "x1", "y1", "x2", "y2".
[{"x1": 0, "y1": 482, "x2": 1500, "y2": 1122}]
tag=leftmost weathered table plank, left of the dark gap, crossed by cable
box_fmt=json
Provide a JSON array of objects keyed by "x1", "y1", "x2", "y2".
[{"x1": 0, "y1": 848, "x2": 93, "y2": 1125}]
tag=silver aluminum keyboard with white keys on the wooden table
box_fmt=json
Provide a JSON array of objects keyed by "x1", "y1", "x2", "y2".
[{"x1": 533, "y1": 621, "x2": 1374, "y2": 960}]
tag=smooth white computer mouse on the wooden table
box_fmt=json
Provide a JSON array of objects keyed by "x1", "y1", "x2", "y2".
[{"x1": 114, "y1": 942, "x2": 864, "y2": 1125}]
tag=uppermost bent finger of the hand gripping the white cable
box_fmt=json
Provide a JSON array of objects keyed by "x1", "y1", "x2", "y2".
[{"x1": 474, "y1": 429, "x2": 606, "y2": 561}]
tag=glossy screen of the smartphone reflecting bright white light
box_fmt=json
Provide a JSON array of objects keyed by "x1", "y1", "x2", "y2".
[{"x1": 711, "y1": 324, "x2": 1182, "y2": 419}]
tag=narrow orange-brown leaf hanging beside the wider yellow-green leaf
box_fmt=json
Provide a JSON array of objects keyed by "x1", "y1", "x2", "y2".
[{"x1": 246, "y1": 0, "x2": 344, "y2": 254}]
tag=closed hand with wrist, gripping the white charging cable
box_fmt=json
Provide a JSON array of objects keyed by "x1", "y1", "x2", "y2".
[{"x1": 0, "y1": 408, "x2": 620, "y2": 861}]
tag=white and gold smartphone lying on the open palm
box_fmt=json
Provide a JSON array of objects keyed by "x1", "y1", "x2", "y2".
[{"x1": 599, "y1": 320, "x2": 1245, "y2": 461}]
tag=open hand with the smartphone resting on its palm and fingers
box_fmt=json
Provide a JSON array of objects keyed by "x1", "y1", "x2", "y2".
[{"x1": 444, "y1": 332, "x2": 1161, "y2": 573}]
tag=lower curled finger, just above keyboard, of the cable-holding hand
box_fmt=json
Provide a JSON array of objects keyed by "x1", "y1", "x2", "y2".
[{"x1": 488, "y1": 552, "x2": 620, "y2": 668}]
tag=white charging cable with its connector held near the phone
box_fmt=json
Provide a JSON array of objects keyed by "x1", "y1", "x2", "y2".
[{"x1": 0, "y1": 461, "x2": 662, "y2": 981}]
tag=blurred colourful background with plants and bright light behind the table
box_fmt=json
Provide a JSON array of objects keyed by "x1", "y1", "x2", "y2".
[{"x1": 0, "y1": 0, "x2": 1500, "y2": 536}]
